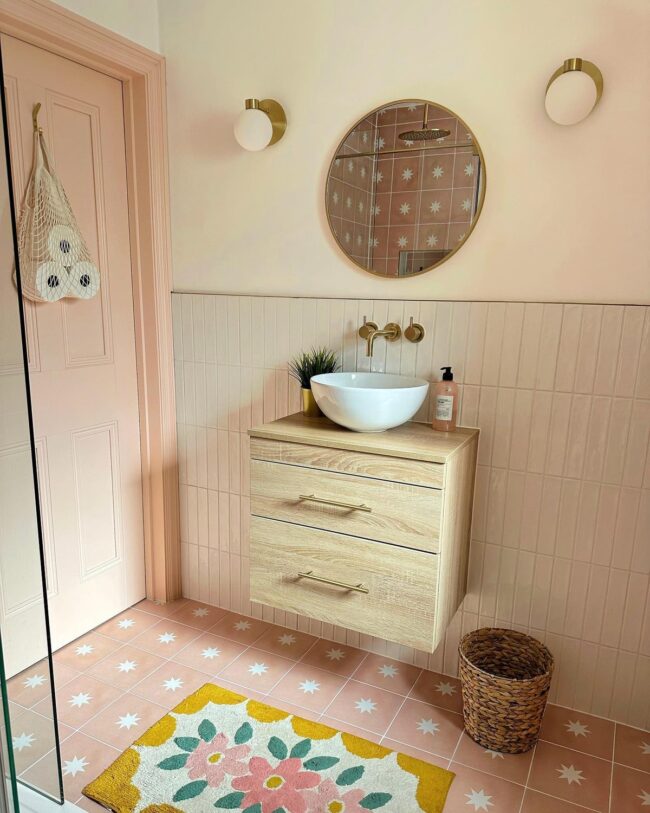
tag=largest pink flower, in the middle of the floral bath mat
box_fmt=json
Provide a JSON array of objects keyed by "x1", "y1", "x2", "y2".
[{"x1": 232, "y1": 757, "x2": 320, "y2": 813}]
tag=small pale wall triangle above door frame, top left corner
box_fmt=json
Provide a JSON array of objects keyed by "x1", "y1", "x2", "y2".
[{"x1": 56, "y1": 0, "x2": 160, "y2": 51}]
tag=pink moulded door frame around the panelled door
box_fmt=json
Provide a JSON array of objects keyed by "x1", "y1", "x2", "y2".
[{"x1": 0, "y1": 0, "x2": 181, "y2": 602}]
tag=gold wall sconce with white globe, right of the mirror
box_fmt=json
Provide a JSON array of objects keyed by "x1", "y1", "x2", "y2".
[{"x1": 545, "y1": 57, "x2": 603, "y2": 125}]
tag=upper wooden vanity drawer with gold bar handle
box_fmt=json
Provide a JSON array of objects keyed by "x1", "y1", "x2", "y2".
[{"x1": 251, "y1": 460, "x2": 443, "y2": 552}]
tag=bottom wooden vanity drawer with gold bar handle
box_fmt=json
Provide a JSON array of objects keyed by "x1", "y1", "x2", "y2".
[{"x1": 250, "y1": 517, "x2": 438, "y2": 652}]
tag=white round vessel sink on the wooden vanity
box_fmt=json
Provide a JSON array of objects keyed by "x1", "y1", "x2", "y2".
[{"x1": 311, "y1": 373, "x2": 429, "y2": 432}]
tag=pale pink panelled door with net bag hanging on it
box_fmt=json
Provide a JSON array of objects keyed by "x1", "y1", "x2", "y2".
[{"x1": 0, "y1": 35, "x2": 145, "y2": 666}]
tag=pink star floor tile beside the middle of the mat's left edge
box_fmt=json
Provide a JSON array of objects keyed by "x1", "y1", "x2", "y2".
[{"x1": 81, "y1": 693, "x2": 166, "y2": 751}]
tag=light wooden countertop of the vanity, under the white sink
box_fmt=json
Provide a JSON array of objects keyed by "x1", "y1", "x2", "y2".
[{"x1": 248, "y1": 412, "x2": 478, "y2": 463}]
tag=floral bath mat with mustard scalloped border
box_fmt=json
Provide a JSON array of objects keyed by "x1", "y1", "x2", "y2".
[{"x1": 83, "y1": 683, "x2": 454, "y2": 813}]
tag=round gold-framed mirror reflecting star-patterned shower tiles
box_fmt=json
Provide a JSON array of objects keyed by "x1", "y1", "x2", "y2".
[{"x1": 325, "y1": 99, "x2": 485, "y2": 279}]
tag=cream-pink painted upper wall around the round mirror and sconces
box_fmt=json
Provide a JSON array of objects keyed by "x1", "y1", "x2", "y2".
[{"x1": 159, "y1": 0, "x2": 650, "y2": 303}]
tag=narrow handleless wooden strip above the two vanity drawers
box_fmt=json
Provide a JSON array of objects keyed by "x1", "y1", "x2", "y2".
[{"x1": 250, "y1": 437, "x2": 445, "y2": 488}]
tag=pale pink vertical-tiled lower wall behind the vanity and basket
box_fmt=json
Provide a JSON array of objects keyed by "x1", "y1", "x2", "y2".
[{"x1": 173, "y1": 294, "x2": 650, "y2": 727}]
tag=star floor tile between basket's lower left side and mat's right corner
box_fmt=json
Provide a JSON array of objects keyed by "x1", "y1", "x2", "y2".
[{"x1": 386, "y1": 699, "x2": 463, "y2": 759}]
